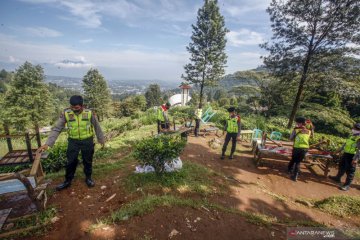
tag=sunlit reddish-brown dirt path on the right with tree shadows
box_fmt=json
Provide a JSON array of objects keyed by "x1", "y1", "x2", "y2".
[{"x1": 182, "y1": 135, "x2": 360, "y2": 229}]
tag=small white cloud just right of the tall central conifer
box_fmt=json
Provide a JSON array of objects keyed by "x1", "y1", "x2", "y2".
[{"x1": 226, "y1": 28, "x2": 264, "y2": 47}]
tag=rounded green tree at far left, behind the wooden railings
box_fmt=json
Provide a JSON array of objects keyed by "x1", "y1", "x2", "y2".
[{"x1": 0, "y1": 62, "x2": 53, "y2": 130}]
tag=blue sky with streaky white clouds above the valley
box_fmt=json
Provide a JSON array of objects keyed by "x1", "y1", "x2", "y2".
[{"x1": 0, "y1": 0, "x2": 271, "y2": 82}]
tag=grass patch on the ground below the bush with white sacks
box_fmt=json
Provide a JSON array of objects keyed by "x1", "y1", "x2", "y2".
[{"x1": 125, "y1": 162, "x2": 225, "y2": 196}]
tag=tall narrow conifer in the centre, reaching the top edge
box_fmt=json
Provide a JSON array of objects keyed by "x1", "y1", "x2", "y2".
[{"x1": 182, "y1": 0, "x2": 228, "y2": 108}]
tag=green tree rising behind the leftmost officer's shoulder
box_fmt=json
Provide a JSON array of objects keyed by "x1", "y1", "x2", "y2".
[{"x1": 82, "y1": 68, "x2": 111, "y2": 121}]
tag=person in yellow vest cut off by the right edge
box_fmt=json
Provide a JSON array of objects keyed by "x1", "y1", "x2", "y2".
[{"x1": 329, "y1": 123, "x2": 360, "y2": 191}]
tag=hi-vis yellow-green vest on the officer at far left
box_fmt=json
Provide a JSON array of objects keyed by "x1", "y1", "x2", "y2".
[{"x1": 65, "y1": 109, "x2": 94, "y2": 140}]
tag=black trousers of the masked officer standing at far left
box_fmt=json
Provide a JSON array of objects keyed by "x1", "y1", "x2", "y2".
[{"x1": 65, "y1": 137, "x2": 95, "y2": 181}]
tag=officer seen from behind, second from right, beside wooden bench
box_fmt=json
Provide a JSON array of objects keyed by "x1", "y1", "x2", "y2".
[{"x1": 288, "y1": 117, "x2": 311, "y2": 181}]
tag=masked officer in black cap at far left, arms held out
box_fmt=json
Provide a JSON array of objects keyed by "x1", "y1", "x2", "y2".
[{"x1": 39, "y1": 95, "x2": 105, "y2": 191}]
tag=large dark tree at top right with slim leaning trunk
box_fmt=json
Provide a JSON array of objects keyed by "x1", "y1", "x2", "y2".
[{"x1": 262, "y1": 0, "x2": 360, "y2": 128}]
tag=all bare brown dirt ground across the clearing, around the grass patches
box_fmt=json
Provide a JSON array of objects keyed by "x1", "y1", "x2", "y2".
[{"x1": 21, "y1": 137, "x2": 360, "y2": 239}]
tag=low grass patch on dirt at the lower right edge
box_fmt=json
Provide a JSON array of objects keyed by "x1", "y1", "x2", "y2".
[{"x1": 314, "y1": 195, "x2": 360, "y2": 217}]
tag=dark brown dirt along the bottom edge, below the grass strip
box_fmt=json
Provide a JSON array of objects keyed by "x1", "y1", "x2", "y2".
[{"x1": 90, "y1": 207, "x2": 286, "y2": 240}]
